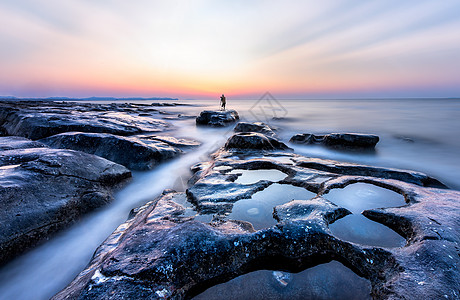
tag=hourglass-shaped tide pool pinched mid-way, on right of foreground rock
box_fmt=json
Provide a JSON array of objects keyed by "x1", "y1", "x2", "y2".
[{"x1": 324, "y1": 183, "x2": 406, "y2": 248}]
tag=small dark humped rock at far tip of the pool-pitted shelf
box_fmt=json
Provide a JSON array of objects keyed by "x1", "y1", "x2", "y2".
[{"x1": 225, "y1": 132, "x2": 290, "y2": 150}]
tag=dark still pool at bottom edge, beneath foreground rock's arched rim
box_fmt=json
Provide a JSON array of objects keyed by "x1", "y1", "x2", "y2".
[{"x1": 193, "y1": 261, "x2": 371, "y2": 300}]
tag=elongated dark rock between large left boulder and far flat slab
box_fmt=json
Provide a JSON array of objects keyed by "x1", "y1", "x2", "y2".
[{"x1": 40, "y1": 132, "x2": 182, "y2": 170}]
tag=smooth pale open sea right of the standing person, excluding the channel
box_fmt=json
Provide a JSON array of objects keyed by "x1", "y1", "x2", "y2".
[{"x1": 171, "y1": 97, "x2": 460, "y2": 189}]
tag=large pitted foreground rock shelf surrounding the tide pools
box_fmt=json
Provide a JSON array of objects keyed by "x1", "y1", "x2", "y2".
[{"x1": 54, "y1": 132, "x2": 460, "y2": 299}]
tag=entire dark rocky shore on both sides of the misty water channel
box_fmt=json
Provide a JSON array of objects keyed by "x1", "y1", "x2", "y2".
[{"x1": 0, "y1": 101, "x2": 460, "y2": 299}]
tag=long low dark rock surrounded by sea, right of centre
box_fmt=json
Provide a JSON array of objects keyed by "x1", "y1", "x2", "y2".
[{"x1": 290, "y1": 133, "x2": 379, "y2": 149}]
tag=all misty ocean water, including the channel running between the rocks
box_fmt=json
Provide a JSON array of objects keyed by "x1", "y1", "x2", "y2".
[{"x1": 0, "y1": 95, "x2": 460, "y2": 299}]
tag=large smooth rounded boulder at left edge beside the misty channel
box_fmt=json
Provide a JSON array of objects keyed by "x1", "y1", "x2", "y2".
[{"x1": 0, "y1": 137, "x2": 131, "y2": 264}]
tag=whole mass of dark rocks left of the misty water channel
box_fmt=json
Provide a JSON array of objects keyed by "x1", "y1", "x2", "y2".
[{"x1": 0, "y1": 101, "x2": 199, "y2": 265}]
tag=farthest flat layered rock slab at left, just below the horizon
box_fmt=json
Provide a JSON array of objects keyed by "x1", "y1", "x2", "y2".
[{"x1": 0, "y1": 101, "x2": 171, "y2": 140}]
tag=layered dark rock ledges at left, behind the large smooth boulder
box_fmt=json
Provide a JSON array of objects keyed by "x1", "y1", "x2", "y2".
[{"x1": 0, "y1": 101, "x2": 200, "y2": 170}]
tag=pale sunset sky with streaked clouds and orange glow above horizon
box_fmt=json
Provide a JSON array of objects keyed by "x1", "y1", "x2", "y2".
[{"x1": 0, "y1": 0, "x2": 460, "y2": 99}]
